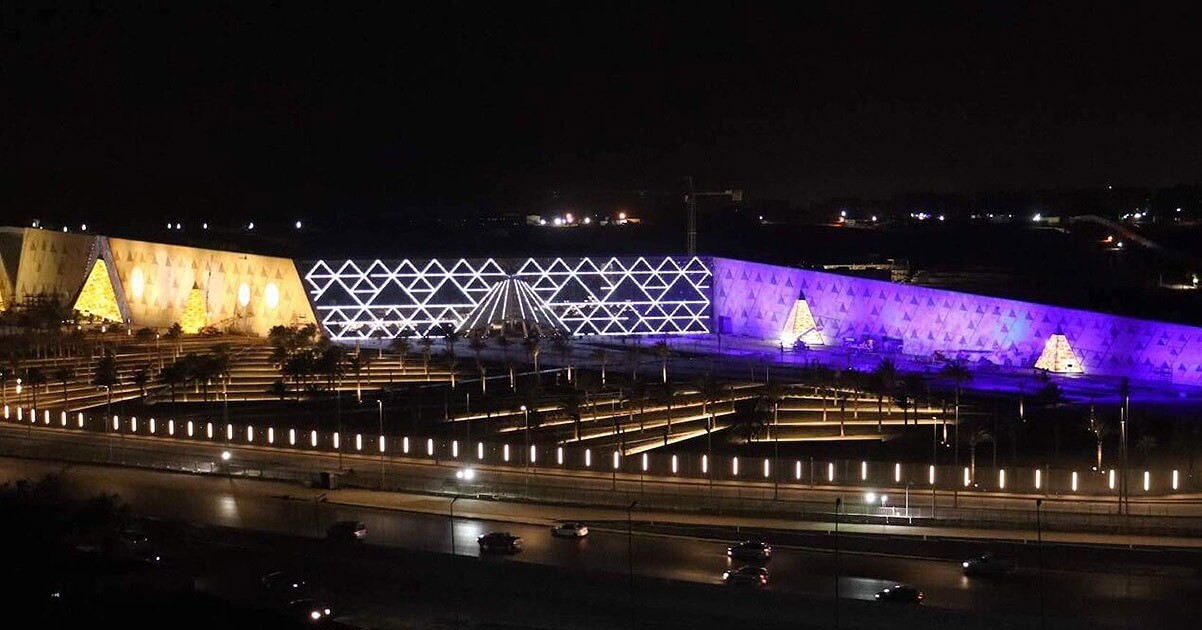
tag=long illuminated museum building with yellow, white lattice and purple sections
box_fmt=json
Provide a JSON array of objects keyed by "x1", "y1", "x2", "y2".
[{"x1": 0, "y1": 227, "x2": 1202, "y2": 386}]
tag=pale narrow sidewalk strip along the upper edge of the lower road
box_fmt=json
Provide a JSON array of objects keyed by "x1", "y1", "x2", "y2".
[{"x1": 327, "y1": 489, "x2": 1202, "y2": 549}]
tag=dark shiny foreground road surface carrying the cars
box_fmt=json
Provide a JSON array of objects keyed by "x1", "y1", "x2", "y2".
[{"x1": 0, "y1": 449, "x2": 1202, "y2": 628}]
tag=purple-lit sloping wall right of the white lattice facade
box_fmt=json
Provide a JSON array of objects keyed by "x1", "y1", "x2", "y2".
[{"x1": 712, "y1": 258, "x2": 1202, "y2": 386}]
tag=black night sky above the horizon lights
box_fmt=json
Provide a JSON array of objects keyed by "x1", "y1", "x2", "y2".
[{"x1": 0, "y1": 1, "x2": 1202, "y2": 222}]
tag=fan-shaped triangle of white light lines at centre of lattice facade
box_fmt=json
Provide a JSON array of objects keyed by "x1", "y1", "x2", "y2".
[{"x1": 458, "y1": 277, "x2": 567, "y2": 337}]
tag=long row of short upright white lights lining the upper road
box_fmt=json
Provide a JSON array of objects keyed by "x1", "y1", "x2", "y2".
[{"x1": 4, "y1": 405, "x2": 1180, "y2": 492}]
